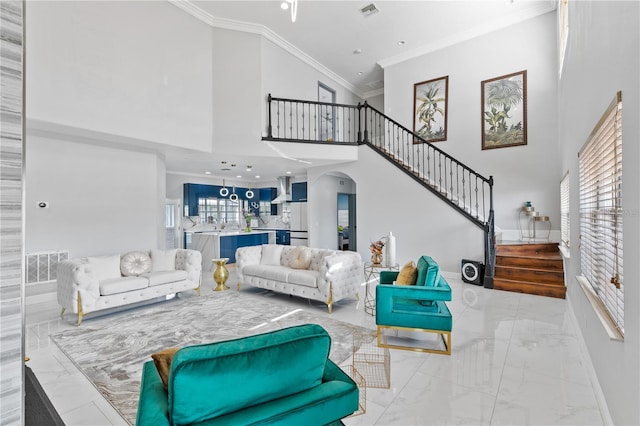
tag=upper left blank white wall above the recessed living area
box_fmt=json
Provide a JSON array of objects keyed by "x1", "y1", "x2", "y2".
[{"x1": 26, "y1": 1, "x2": 212, "y2": 151}]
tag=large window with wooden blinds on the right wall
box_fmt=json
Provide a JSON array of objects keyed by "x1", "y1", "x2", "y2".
[{"x1": 578, "y1": 92, "x2": 624, "y2": 335}]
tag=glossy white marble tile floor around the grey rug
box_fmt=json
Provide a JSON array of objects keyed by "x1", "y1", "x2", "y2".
[{"x1": 25, "y1": 268, "x2": 608, "y2": 426}]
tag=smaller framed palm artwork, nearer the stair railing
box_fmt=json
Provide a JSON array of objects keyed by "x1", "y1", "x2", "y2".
[{"x1": 413, "y1": 76, "x2": 449, "y2": 143}]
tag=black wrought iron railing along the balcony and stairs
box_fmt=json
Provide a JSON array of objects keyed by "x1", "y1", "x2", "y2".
[{"x1": 263, "y1": 95, "x2": 495, "y2": 288}]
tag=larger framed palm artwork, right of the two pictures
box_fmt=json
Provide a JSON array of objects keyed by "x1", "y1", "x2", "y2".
[{"x1": 482, "y1": 70, "x2": 527, "y2": 149}]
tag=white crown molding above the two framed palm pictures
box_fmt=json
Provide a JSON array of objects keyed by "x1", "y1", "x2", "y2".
[{"x1": 378, "y1": 2, "x2": 556, "y2": 68}]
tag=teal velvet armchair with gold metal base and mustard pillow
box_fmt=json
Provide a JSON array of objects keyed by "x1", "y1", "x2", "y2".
[{"x1": 376, "y1": 256, "x2": 453, "y2": 355}]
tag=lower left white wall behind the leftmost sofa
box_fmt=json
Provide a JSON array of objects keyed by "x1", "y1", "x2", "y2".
[{"x1": 25, "y1": 135, "x2": 164, "y2": 257}]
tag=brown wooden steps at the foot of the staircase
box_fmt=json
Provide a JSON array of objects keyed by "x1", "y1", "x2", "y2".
[{"x1": 493, "y1": 243, "x2": 567, "y2": 299}]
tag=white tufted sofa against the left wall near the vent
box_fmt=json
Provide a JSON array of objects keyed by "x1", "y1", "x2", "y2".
[{"x1": 58, "y1": 249, "x2": 202, "y2": 325}]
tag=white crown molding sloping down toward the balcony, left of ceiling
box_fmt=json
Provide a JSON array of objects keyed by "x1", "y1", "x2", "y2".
[{"x1": 167, "y1": 0, "x2": 364, "y2": 98}]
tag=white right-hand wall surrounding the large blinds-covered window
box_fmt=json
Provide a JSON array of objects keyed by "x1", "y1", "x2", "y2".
[{"x1": 558, "y1": 1, "x2": 640, "y2": 425}]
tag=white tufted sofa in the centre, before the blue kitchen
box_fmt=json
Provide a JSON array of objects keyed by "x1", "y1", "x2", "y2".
[{"x1": 236, "y1": 244, "x2": 364, "y2": 313}]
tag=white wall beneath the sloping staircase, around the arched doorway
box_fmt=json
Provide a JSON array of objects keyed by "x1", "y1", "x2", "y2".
[{"x1": 307, "y1": 146, "x2": 484, "y2": 273}]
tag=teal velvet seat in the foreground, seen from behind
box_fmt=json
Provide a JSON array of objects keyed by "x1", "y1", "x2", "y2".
[{"x1": 136, "y1": 324, "x2": 358, "y2": 426}]
